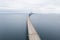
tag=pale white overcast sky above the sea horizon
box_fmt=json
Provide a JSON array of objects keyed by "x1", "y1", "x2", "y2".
[{"x1": 0, "y1": 0, "x2": 60, "y2": 13}]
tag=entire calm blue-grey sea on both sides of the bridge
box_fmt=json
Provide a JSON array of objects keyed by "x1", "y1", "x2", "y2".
[{"x1": 0, "y1": 13, "x2": 60, "y2": 40}]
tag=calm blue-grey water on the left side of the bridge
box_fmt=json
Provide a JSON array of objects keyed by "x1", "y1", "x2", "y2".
[{"x1": 0, "y1": 14, "x2": 26, "y2": 40}]
